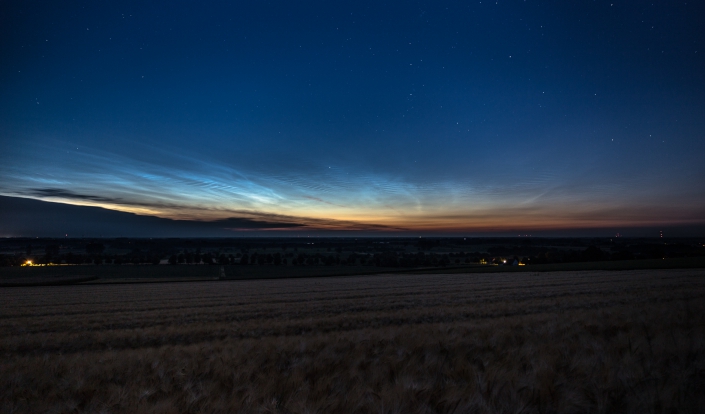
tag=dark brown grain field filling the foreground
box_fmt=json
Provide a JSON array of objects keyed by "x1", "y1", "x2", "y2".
[{"x1": 0, "y1": 269, "x2": 705, "y2": 413}]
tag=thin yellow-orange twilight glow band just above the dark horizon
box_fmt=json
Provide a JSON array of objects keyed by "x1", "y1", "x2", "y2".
[{"x1": 16, "y1": 193, "x2": 703, "y2": 234}]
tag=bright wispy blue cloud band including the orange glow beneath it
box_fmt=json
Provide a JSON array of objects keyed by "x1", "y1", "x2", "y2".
[{"x1": 0, "y1": 136, "x2": 701, "y2": 230}]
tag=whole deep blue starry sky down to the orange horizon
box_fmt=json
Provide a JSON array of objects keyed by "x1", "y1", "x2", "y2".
[{"x1": 0, "y1": 0, "x2": 705, "y2": 236}]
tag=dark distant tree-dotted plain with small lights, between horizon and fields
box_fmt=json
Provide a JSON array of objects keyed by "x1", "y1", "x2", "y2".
[{"x1": 0, "y1": 238, "x2": 705, "y2": 267}]
